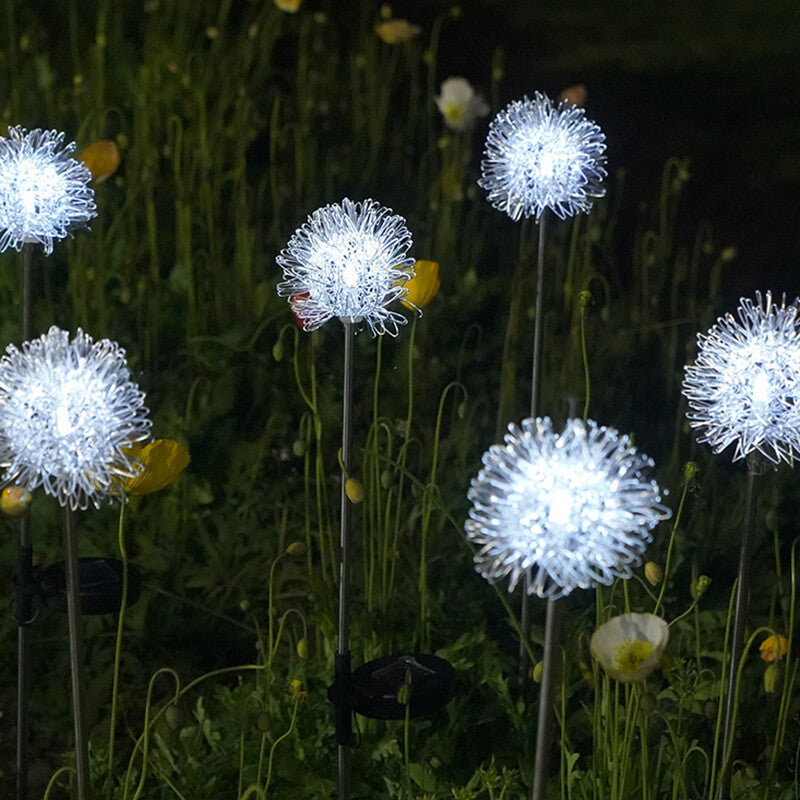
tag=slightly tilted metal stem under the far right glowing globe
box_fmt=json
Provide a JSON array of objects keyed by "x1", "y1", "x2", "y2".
[{"x1": 718, "y1": 455, "x2": 760, "y2": 800}]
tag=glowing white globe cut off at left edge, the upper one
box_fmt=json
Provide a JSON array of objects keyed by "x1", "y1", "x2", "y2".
[{"x1": 0, "y1": 127, "x2": 97, "y2": 255}]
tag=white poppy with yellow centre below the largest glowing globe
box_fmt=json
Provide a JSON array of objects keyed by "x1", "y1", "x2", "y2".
[{"x1": 590, "y1": 614, "x2": 669, "y2": 683}]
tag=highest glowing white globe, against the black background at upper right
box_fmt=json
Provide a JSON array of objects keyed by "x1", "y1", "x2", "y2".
[{"x1": 478, "y1": 92, "x2": 606, "y2": 221}]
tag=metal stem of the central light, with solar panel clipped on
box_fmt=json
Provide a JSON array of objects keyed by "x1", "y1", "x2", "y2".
[{"x1": 334, "y1": 319, "x2": 353, "y2": 800}]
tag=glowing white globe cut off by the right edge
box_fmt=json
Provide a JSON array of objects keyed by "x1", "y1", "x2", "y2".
[{"x1": 683, "y1": 292, "x2": 800, "y2": 465}]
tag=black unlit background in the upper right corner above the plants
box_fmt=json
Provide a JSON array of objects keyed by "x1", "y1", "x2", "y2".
[{"x1": 404, "y1": 0, "x2": 800, "y2": 303}]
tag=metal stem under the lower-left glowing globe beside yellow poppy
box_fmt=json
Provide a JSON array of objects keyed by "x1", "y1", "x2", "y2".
[{"x1": 64, "y1": 508, "x2": 89, "y2": 800}]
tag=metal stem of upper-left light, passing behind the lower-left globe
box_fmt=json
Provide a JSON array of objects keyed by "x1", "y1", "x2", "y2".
[{"x1": 16, "y1": 243, "x2": 34, "y2": 800}]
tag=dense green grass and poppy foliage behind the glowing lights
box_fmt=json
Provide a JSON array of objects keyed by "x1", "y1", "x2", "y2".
[{"x1": 0, "y1": 0, "x2": 800, "y2": 800}]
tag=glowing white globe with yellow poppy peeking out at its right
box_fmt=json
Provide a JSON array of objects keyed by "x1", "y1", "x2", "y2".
[{"x1": 275, "y1": 198, "x2": 414, "y2": 336}]
